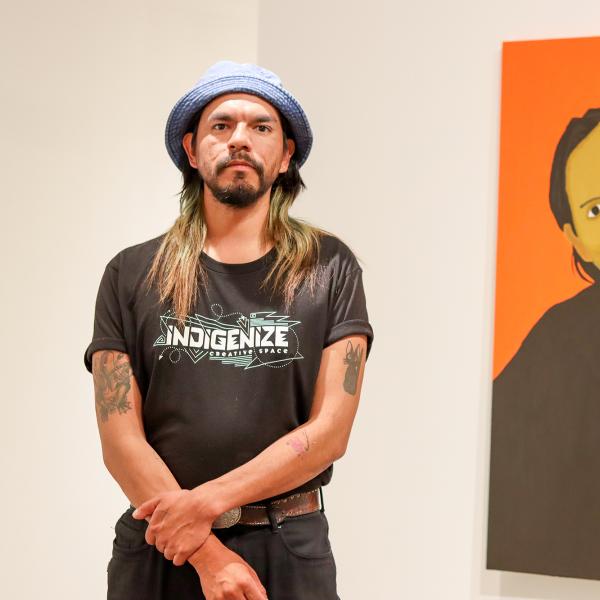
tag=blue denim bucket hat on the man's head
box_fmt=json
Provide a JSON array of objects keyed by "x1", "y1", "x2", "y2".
[{"x1": 165, "y1": 60, "x2": 313, "y2": 171}]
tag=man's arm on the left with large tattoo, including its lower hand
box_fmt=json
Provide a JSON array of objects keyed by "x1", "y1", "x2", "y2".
[{"x1": 92, "y1": 350, "x2": 264, "y2": 597}]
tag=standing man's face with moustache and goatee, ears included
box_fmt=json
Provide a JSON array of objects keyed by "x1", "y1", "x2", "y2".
[{"x1": 183, "y1": 93, "x2": 294, "y2": 208}]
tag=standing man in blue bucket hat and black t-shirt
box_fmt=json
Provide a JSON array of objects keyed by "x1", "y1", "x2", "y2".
[{"x1": 85, "y1": 61, "x2": 373, "y2": 600}]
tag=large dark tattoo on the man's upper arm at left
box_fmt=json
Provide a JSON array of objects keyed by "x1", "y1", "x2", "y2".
[{"x1": 92, "y1": 350, "x2": 131, "y2": 421}]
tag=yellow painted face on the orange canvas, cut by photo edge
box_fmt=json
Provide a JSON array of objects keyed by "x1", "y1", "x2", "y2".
[{"x1": 563, "y1": 124, "x2": 600, "y2": 268}]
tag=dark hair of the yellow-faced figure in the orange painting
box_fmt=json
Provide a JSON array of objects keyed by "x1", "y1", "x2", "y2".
[{"x1": 550, "y1": 108, "x2": 600, "y2": 282}]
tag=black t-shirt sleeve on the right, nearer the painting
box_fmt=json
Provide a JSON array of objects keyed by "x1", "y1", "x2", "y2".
[{"x1": 323, "y1": 267, "x2": 374, "y2": 360}]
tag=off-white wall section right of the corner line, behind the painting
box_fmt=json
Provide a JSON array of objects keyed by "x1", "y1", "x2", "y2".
[{"x1": 258, "y1": 0, "x2": 600, "y2": 600}]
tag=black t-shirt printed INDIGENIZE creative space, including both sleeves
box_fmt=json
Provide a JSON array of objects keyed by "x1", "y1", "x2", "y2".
[{"x1": 84, "y1": 234, "x2": 373, "y2": 501}]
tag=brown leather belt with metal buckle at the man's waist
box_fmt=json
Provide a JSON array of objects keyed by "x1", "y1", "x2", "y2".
[{"x1": 212, "y1": 488, "x2": 323, "y2": 529}]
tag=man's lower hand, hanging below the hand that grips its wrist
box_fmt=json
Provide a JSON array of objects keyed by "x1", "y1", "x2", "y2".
[{"x1": 190, "y1": 535, "x2": 268, "y2": 600}]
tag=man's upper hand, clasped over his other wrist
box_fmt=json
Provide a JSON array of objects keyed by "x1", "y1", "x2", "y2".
[{"x1": 132, "y1": 489, "x2": 218, "y2": 567}]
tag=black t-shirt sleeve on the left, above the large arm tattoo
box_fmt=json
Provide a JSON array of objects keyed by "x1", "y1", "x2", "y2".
[{"x1": 84, "y1": 255, "x2": 127, "y2": 373}]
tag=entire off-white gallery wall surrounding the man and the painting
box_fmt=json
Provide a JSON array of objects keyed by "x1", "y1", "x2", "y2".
[{"x1": 0, "y1": 0, "x2": 600, "y2": 600}]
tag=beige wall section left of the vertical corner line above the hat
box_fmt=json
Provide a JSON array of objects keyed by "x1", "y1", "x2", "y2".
[{"x1": 0, "y1": 0, "x2": 258, "y2": 600}]
